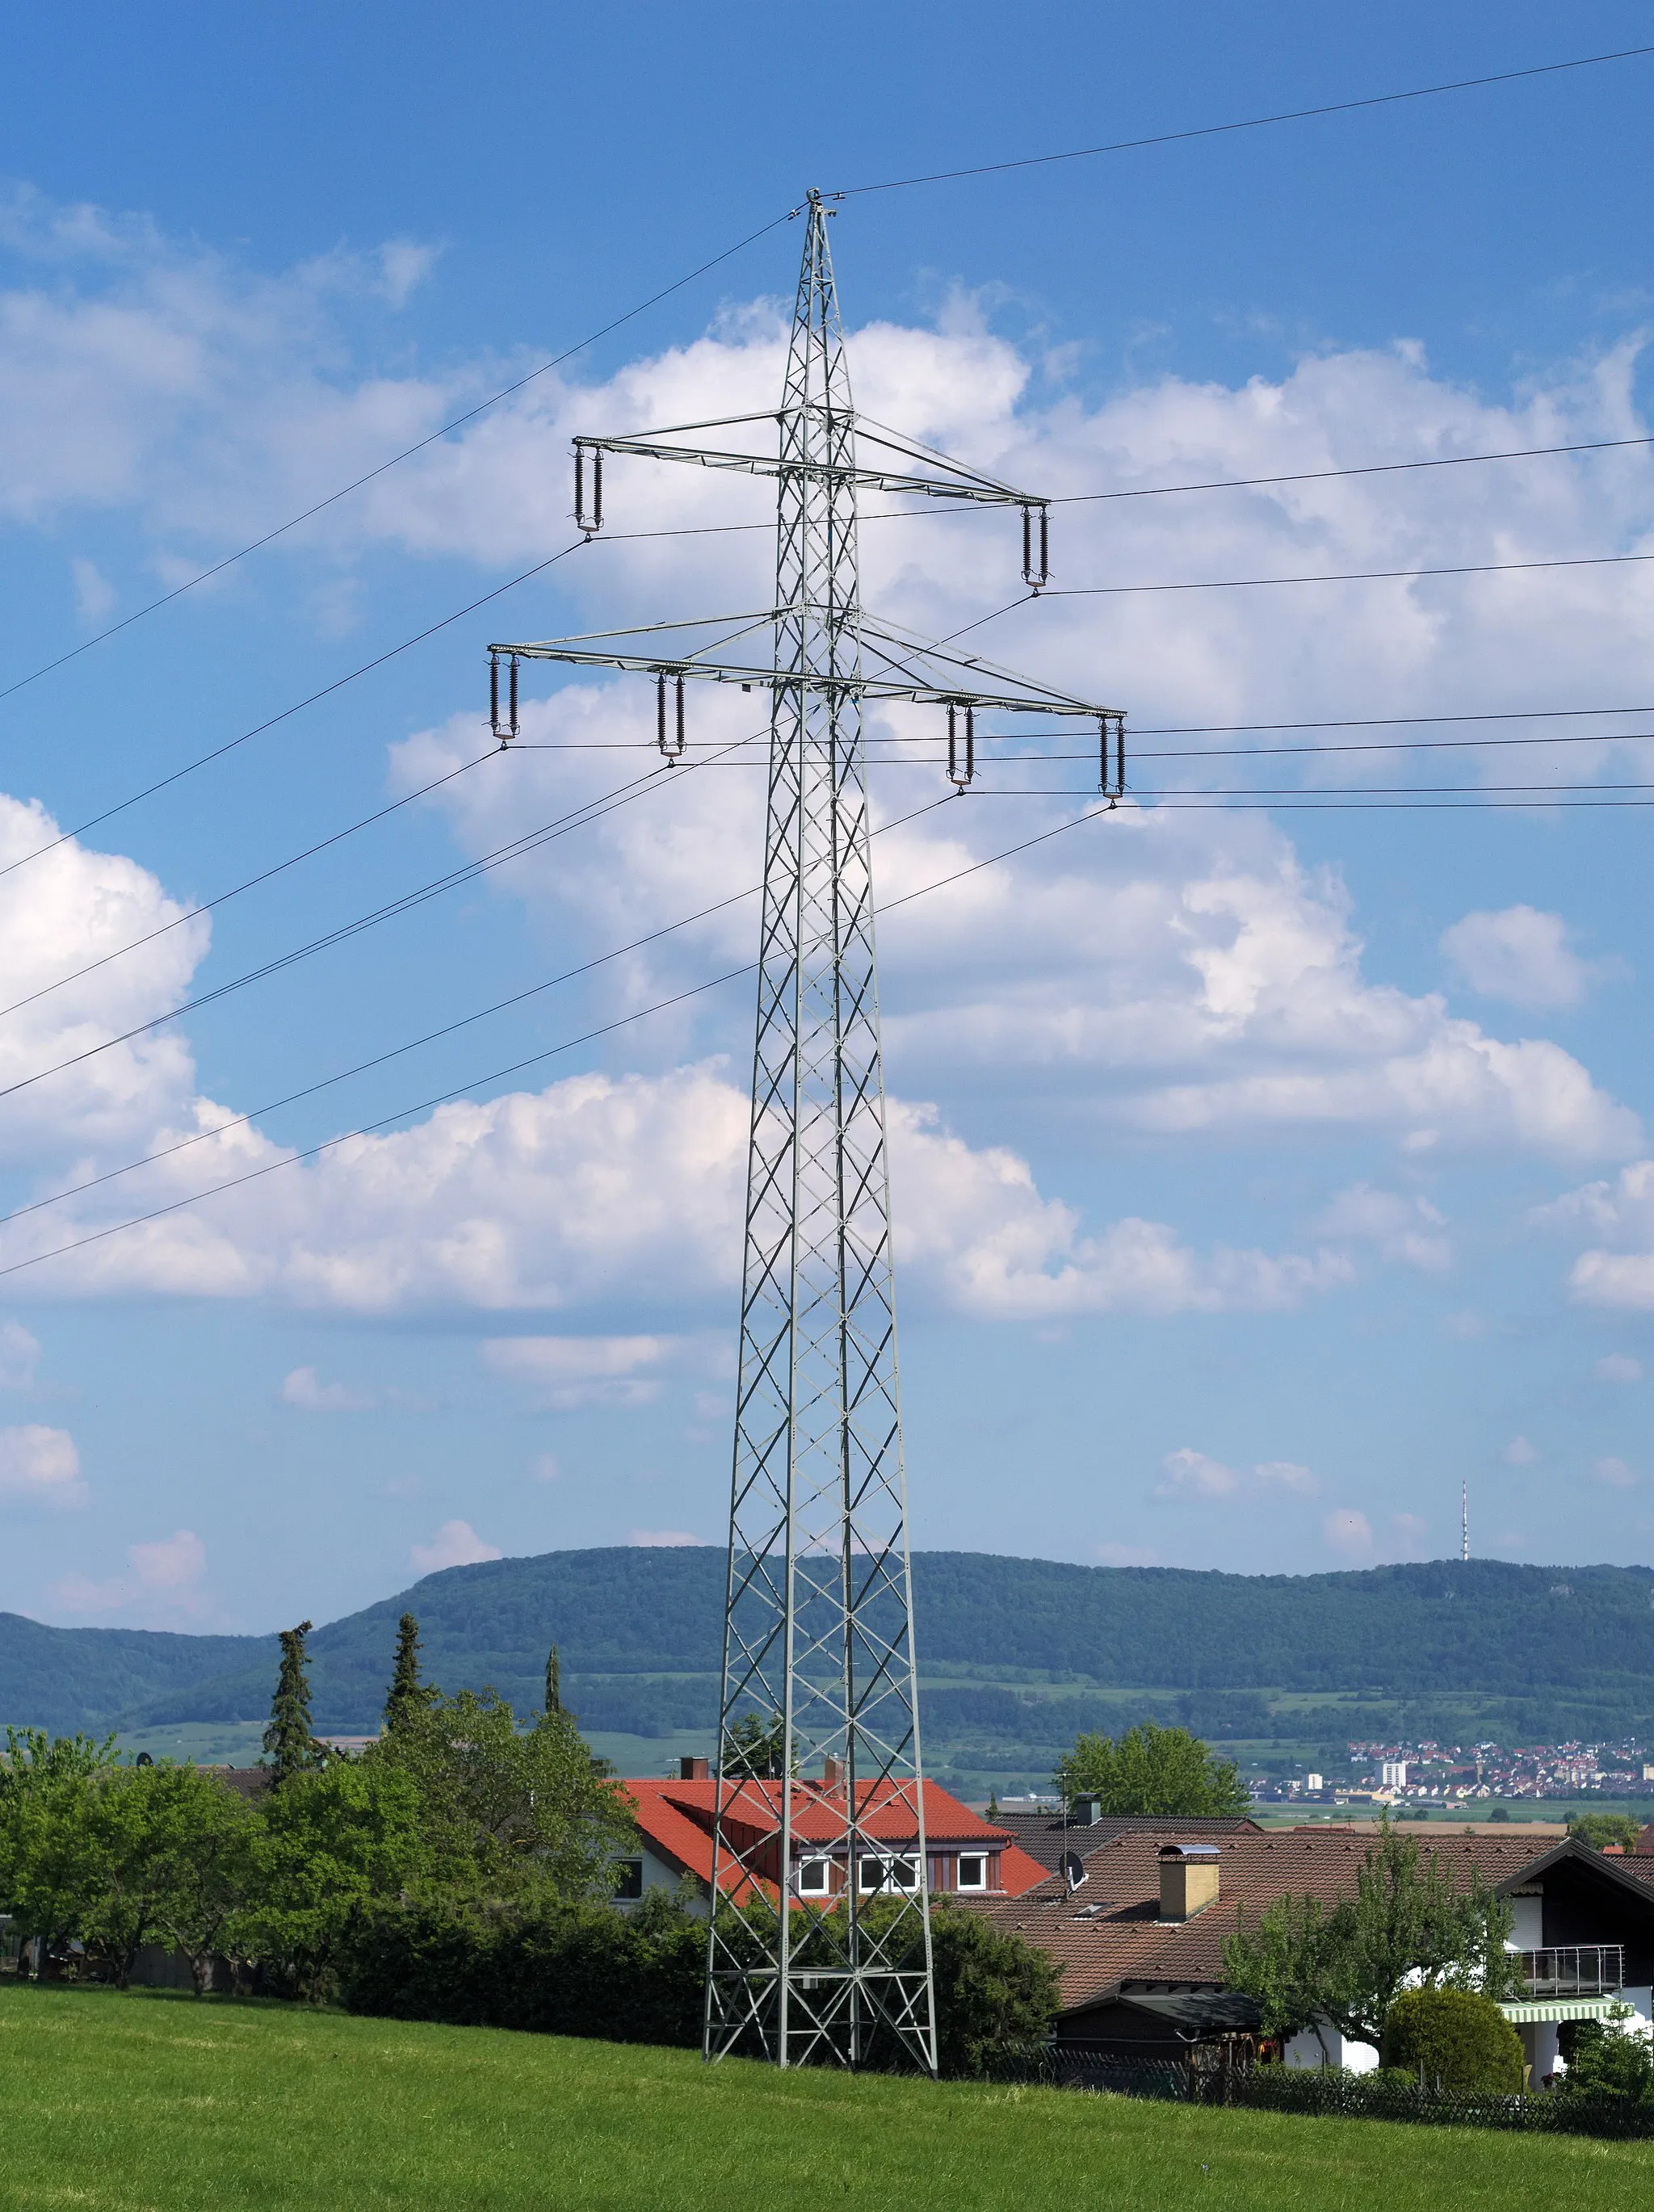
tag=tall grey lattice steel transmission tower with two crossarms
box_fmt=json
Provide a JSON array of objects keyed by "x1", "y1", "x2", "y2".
[{"x1": 491, "y1": 192, "x2": 1126, "y2": 2072}]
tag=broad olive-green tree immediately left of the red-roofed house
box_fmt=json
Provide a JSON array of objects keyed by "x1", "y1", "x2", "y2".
[{"x1": 363, "y1": 1690, "x2": 632, "y2": 1898}]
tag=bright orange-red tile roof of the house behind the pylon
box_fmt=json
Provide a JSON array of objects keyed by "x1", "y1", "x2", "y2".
[{"x1": 621, "y1": 1778, "x2": 1046, "y2": 1904}]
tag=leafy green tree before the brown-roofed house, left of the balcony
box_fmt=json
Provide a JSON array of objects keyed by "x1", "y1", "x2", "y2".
[{"x1": 1223, "y1": 1825, "x2": 1522, "y2": 2044}]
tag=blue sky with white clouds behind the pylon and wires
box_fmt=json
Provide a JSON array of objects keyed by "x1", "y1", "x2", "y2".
[{"x1": 0, "y1": 6, "x2": 1654, "y2": 1628}]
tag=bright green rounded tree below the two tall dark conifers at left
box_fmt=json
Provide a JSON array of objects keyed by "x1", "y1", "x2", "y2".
[{"x1": 232, "y1": 1761, "x2": 431, "y2": 2000}]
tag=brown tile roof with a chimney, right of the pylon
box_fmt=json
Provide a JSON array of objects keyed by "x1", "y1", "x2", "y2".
[{"x1": 973, "y1": 1825, "x2": 1574, "y2": 2013}]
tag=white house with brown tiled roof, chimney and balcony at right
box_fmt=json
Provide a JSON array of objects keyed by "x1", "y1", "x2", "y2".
[{"x1": 973, "y1": 1823, "x2": 1654, "y2": 2080}]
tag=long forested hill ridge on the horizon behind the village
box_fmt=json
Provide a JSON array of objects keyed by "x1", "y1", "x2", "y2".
[{"x1": 0, "y1": 1547, "x2": 1654, "y2": 1730}]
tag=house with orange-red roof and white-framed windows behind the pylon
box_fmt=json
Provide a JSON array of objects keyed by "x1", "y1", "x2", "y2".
[{"x1": 617, "y1": 1759, "x2": 1046, "y2": 1907}]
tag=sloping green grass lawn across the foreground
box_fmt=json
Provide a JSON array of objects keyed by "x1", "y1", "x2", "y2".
[{"x1": 0, "y1": 1987, "x2": 1654, "y2": 2212}]
